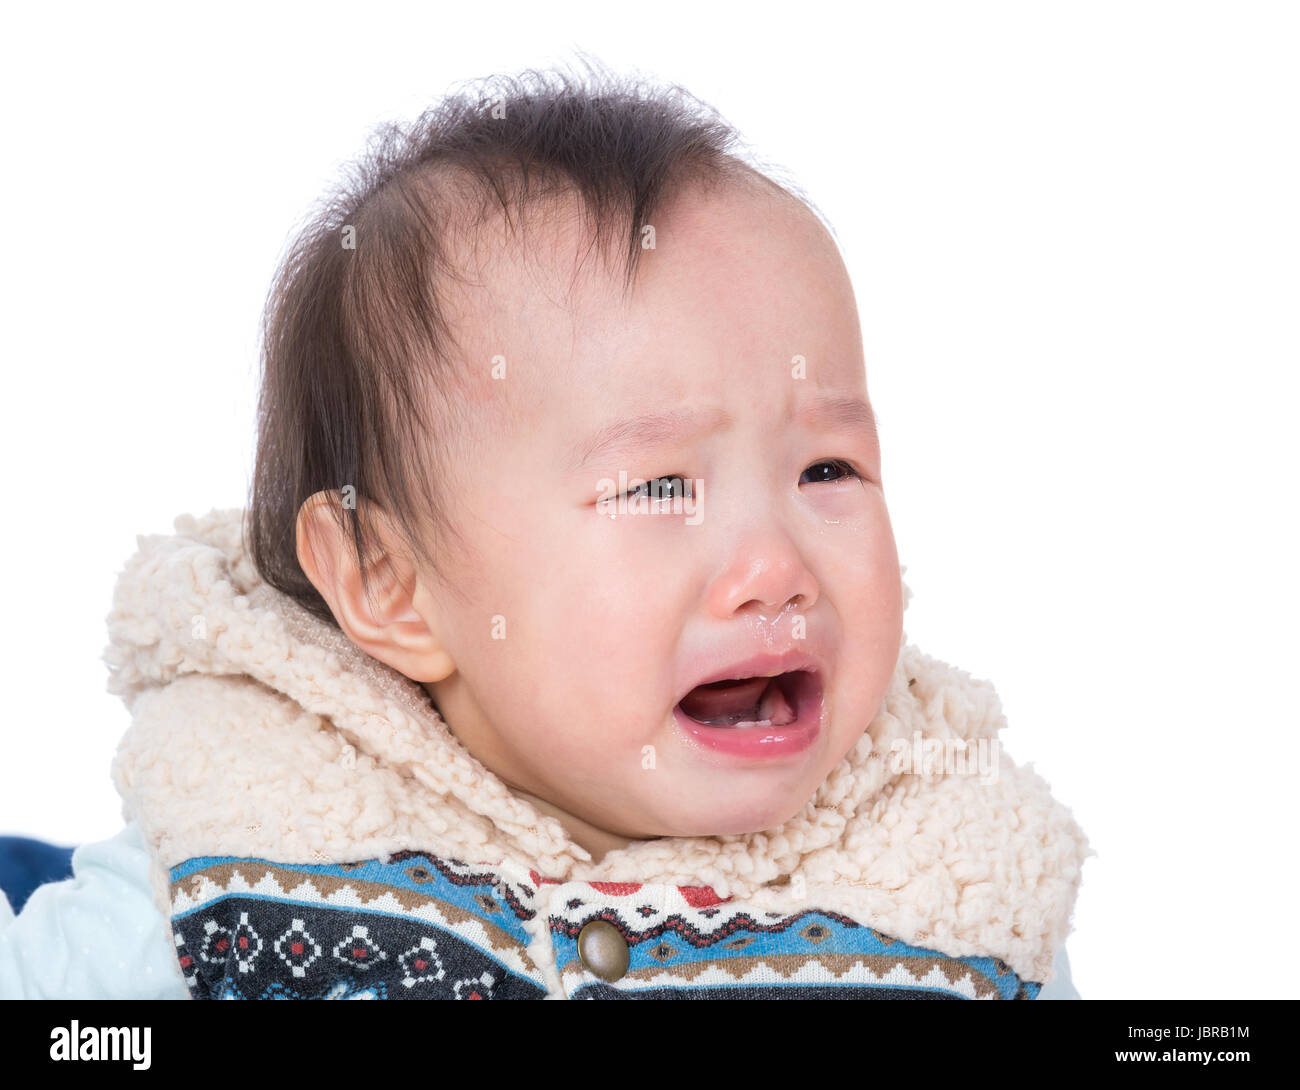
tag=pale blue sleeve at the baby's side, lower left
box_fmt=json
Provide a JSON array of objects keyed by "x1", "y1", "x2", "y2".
[{"x1": 0, "y1": 825, "x2": 189, "y2": 999}]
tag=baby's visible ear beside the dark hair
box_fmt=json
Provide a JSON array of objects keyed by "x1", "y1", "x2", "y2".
[{"x1": 296, "y1": 492, "x2": 456, "y2": 682}]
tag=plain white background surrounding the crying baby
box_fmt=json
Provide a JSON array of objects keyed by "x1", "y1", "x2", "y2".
[{"x1": 0, "y1": 0, "x2": 1300, "y2": 998}]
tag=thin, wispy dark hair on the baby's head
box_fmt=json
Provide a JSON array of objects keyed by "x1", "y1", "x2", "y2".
[{"x1": 248, "y1": 57, "x2": 807, "y2": 624}]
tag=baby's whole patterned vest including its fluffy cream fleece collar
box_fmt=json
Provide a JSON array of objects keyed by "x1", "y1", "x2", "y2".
[{"x1": 96, "y1": 510, "x2": 1092, "y2": 999}]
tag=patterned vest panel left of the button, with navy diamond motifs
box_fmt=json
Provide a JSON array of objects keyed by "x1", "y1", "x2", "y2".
[{"x1": 170, "y1": 852, "x2": 546, "y2": 999}]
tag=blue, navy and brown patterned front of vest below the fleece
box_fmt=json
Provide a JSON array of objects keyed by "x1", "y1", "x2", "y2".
[{"x1": 170, "y1": 851, "x2": 1041, "y2": 999}]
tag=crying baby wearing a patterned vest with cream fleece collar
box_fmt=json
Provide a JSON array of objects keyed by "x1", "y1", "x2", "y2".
[{"x1": 0, "y1": 57, "x2": 1089, "y2": 999}]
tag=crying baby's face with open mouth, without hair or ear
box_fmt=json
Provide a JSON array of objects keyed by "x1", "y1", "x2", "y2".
[{"x1": 421, "y1": 175, "x2": 902, "y2": 838}]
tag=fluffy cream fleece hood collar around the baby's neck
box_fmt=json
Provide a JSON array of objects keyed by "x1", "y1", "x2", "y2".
[{"x1": 104, "y1": 510, "x2": 1095, "y2": 982}]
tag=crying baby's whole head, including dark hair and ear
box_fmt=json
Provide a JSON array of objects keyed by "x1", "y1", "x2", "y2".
[{"x1": 251, "y1": 64, "x2": 902, "y2": 856}]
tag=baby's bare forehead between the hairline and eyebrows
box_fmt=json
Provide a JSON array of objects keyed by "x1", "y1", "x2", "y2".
[{"x1": 445, "y1": 181, "x2": 862, "y2": 416}]
